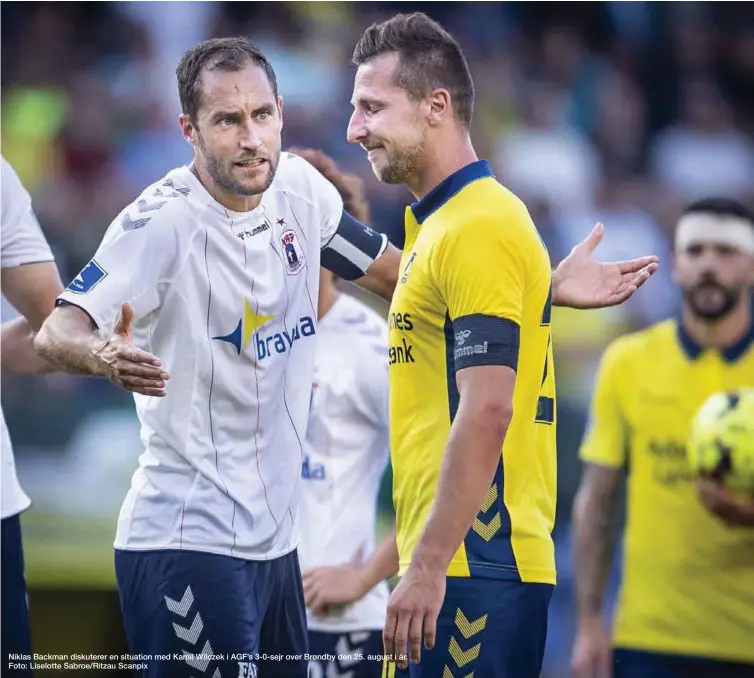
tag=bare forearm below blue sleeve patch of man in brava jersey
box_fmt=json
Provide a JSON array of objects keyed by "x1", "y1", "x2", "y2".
[{"x1": 34, "y1": 307, "x2": 106, "y2": 377}]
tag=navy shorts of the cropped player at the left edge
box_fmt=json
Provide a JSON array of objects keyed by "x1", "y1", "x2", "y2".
[{"x1": 0, "y1": 515, "x2": 32, "y2": 676}]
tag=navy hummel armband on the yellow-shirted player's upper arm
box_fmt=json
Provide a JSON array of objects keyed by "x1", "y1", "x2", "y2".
[{"x1": 452, "y1": 313, "x2": 521, "y2": 371}]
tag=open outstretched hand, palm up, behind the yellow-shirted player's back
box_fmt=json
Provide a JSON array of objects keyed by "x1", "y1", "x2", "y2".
[{"x1": 552, "y1": 224, "x2": 659, "y2": 309}]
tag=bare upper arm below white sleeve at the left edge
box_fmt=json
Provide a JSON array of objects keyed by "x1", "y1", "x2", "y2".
[{"x1": 2, "y1": 261, "x2": 63, "y2": 330}]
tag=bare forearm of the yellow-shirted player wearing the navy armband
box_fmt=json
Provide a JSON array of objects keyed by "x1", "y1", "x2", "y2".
[{"x1": 412, "y1": 406, "x2": 507, "y2": 569}]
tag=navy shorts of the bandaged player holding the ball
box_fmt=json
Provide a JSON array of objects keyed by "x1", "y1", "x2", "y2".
[{"x1": 613, "y1": 648, "x2": 754, "y2": 678}]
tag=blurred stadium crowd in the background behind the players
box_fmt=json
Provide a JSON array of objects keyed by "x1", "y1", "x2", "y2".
[{"x1": 2, "y1": 2, "x2": 754, "y2": 676}]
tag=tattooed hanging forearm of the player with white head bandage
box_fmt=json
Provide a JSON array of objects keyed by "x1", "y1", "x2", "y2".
[{"x1": 573, "y1": 472, "x2": 617, "y2": 619}]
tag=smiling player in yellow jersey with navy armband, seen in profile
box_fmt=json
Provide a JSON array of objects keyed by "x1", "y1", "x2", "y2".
[{"x1": 348, "y1": 14, "x2": 656, "y2": 678}]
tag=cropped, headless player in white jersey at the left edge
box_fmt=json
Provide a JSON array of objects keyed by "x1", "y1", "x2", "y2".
[{"x1": 0, "y1": 158, "x2": 63, "y2": 676}]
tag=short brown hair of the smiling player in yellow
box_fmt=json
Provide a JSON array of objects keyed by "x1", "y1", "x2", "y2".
[{"x1": 352, "y1": 12, "x2": 474, "y2": 128}]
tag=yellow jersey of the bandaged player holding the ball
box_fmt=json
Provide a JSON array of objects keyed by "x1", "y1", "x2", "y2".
[{"x1": 581, "y1": 320, "x2": 754, "y2": 662}]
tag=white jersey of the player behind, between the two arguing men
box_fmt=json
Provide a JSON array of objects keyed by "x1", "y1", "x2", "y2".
[{"x1": 298, "y1": 295, "x2": 389, "y2": 632}]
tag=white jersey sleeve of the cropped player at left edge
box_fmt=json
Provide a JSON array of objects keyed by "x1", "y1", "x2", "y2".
[{"x1": 0, "y1": 158, "x2": 54, "y2": 268}]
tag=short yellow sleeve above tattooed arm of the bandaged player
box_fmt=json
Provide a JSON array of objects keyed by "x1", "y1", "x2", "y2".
[{"x1": 579, "y1": 340, "x2": 629, "y2": 468}]
